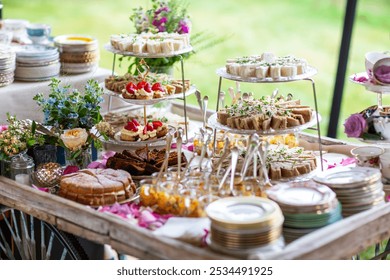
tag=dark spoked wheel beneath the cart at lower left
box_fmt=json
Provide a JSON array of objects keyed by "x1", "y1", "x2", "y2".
[{"x1": 0, "y1": 205, "x2": 88, "y2": 260}]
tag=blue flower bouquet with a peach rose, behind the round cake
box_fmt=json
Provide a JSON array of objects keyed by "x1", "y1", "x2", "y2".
[{"x1": 33, "y1": 78, "x2": 111, "y2": 168}]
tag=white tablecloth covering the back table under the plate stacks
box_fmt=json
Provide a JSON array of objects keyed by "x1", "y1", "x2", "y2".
[{"x1": 0, "y1": 68, "x2": 128, "y2": 125}]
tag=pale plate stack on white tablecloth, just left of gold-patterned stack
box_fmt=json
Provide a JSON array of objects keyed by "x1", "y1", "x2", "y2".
[{"x1": 15, "y1": 45, "x2": 60, "y2": 82}]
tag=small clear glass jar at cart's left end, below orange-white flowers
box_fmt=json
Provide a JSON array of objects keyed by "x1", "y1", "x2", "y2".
[{"x1": 11, "y1": 153, "x2": 35, "y2": 185}]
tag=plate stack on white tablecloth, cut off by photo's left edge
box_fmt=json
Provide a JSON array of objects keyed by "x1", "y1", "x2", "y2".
[{"x1": 0, "y1": 45, "x2": 15, "y2": 87}]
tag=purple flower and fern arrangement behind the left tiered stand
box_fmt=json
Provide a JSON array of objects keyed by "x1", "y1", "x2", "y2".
[{"x1": 125, "y1": 0, "x2": 225, "y2": 73}]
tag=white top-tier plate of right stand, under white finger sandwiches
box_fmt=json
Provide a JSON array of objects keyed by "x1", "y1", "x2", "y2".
[{"x1": 216, "y1": 66, "x2": 317, "y2": 83}]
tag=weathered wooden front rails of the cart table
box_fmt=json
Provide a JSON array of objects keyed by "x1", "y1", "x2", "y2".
[{"x1": 0, "y1": 176, "x2": 390, "y2": 259}]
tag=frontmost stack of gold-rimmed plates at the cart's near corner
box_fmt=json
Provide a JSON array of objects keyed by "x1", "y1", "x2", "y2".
[{"x1": 206, "y1": 197, "x2": 284, "y2": 255}]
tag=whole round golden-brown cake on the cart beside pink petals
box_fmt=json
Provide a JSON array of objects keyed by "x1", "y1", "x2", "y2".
[{"x1": 59, "y1": 169, "x2": 136, "y2": 206}]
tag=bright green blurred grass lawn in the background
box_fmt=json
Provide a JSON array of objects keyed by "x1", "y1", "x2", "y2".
[{"x1": 3, "y1": 0, "x2": 390, "y2": 138}]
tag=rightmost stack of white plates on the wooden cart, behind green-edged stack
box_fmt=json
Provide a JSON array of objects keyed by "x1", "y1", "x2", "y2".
[{"x1": 314, "y1": 167, "x2": 385, "y2": 217}]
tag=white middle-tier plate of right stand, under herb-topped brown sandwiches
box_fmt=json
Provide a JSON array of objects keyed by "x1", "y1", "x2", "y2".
[{"x1": 208, "y1": 111, "x2": 321, "y2": 135}]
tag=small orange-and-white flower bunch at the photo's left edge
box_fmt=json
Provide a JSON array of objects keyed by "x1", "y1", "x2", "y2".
[{"x1": 0, "y1": 113, "x2": 44, "y2": 160}]
